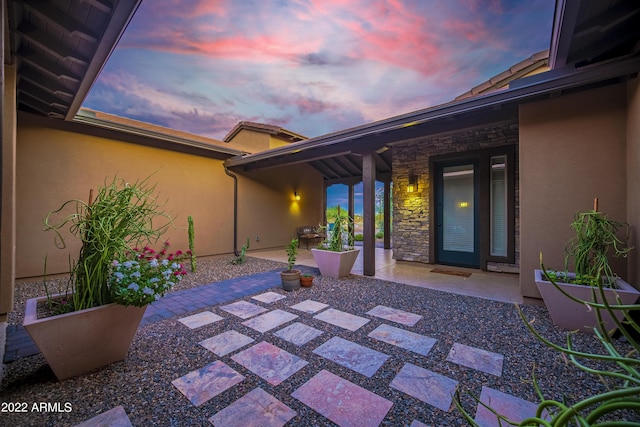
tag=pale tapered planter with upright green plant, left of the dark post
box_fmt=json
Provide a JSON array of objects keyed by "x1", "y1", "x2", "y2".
[{"x1": 311, "y1": 206, "x2": 360, "y2": 278}]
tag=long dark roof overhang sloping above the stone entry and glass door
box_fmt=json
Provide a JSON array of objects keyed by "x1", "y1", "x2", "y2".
[{"x1": 225, "y1": 57, "x2": 640, "y2": 179}]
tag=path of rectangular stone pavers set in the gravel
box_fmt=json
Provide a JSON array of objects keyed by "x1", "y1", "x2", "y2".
[{"x1": 81, "y1": 292, "x2": 537, "y2": 427}]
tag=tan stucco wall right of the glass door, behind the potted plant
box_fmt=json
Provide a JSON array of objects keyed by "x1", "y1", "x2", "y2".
[{"x1": 520, "y1": 84, "x2": 631, "y2": 297}]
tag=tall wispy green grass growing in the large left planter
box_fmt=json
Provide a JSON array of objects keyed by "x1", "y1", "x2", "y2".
[{"x1": 44, "y1": 177, "x2": 171, "y2": 310}]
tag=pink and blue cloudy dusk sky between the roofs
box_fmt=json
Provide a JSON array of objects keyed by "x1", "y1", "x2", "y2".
[{"x1": 83, "y1": 0, "x2": 555, "y2": 139}]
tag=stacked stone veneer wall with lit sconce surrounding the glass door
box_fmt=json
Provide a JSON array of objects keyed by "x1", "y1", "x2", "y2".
[{"x1": 393, "y1": 122, "x2": 520, "y2": 272}]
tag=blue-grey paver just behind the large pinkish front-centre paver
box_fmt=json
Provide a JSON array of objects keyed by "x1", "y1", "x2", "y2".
[{"x1": 313, "y1": 337, "x2": 389, "y2": 378}]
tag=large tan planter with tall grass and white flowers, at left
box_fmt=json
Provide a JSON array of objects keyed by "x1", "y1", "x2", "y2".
[{"x1": 24, "y1": 178, "x2": 184, "y2": 380}]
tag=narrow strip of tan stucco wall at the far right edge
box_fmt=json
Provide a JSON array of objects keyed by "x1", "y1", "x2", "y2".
[{"x1": 626, "y1": 78, "x2": 640, "y2": 288}]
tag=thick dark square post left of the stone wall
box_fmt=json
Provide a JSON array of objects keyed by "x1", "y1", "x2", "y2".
[{"x1": 362, "y1": 153, "x2": 376, "y2": 276}]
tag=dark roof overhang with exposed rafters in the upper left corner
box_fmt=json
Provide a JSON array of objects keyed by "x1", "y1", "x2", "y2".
[{"x1": 5, "y1": 0, "x2": 141, "y2": 120}]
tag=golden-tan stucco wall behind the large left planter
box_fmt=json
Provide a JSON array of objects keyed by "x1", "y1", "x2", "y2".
[{"x1": 16, "y1": 118, "x2": 322, "y2": 277}]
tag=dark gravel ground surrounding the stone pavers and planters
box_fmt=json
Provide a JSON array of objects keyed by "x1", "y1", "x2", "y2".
[{"x1": 0, "y1": 257, "x2": 636, "y2": 426}]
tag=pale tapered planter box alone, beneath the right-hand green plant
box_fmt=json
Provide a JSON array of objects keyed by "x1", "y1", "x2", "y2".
[{"x1": 535, "y1": 270, "x2": 640, "y2": 333}]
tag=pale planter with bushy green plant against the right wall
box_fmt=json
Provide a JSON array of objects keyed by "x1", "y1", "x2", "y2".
[{"x1": 535, "y1": 199, "x2": 640, "y2": 334}]
